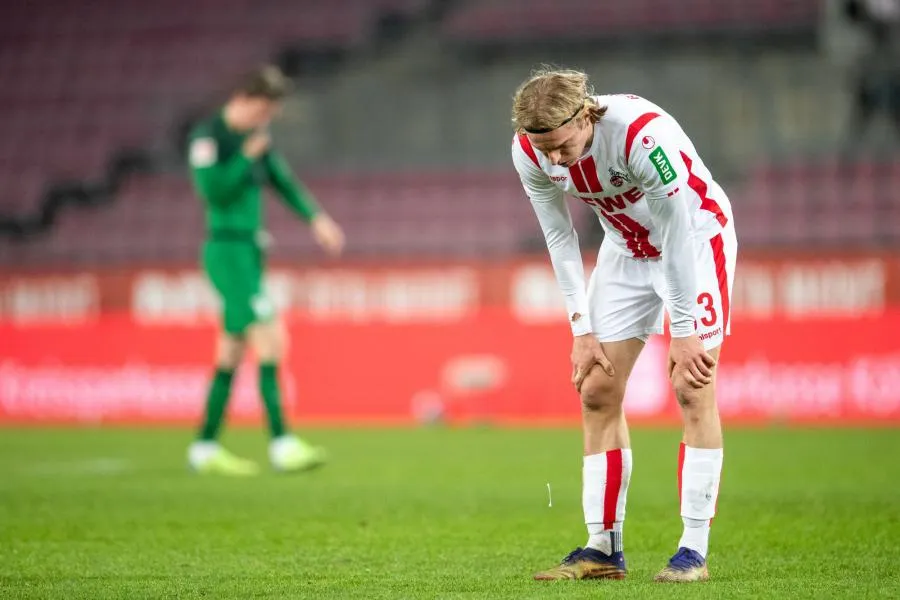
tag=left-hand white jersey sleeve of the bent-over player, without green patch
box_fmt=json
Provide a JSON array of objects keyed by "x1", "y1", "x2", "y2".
[{"x1": 512, "y1": 138, "x2": 593, "y2": 336}]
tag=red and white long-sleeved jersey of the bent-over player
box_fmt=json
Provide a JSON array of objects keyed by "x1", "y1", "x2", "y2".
[{"x1": 512, "y1": 95, "x2": 732, "y2": 337}]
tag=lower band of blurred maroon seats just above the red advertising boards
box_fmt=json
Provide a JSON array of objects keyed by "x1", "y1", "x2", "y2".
[{"x1": 0, "y1": 159, "x2": 900, "y2": 266}]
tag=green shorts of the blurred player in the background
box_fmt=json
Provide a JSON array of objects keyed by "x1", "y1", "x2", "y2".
[{"x1": 202, "y1": 239, "x2": 275, "y2": 336}]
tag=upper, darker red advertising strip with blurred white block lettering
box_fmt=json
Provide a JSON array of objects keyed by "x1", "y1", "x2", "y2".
[{"x1": 0, "y1": 252, "x2": 900, "y2": 323}]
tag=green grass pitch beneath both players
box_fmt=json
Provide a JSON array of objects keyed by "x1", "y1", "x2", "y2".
[{"x1": 0, "y1": 429, "x2": 900, "y2": 599}]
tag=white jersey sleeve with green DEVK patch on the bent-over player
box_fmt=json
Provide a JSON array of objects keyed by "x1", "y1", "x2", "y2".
[{"x1": 625, "y1": 118, "x2": 697, "y2": 337}]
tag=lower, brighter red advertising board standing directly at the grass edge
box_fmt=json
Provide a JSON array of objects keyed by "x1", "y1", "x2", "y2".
[{"x1": 0, "y1": 308, "x2": 900, "y2": 425}]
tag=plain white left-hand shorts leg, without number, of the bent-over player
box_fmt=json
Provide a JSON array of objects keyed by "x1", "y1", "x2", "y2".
[{"x1": 588, "y1": 244, "x2": 664, "y2": 342}]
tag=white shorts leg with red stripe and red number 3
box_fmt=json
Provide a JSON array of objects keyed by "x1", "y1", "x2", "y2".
[{"x1": 694, "y1": 225, "x2": 737, "y2": 350}]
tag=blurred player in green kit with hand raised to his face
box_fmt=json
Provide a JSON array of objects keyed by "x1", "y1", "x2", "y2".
[{"x1": 188, "y1": 66, "x2": 344, "y2": 475}]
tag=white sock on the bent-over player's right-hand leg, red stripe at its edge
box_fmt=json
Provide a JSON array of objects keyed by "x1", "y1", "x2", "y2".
[{"x1": 678, "y1": 443, "x2": 723, "y2": 558}]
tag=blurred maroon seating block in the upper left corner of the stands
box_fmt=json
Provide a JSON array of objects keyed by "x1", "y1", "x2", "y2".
[{"x1": 0, "y1": 0, "x2": 425, "y2": 220}]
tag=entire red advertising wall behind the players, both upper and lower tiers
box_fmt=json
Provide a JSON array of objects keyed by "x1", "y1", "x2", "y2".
[{"x1": 0, "y1": 253, "x2": 900, "y2": 424}]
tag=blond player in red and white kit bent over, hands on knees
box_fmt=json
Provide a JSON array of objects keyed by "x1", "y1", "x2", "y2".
[{"x1": 512, "y1": 69, "x2": 737, "y2": 581}]
